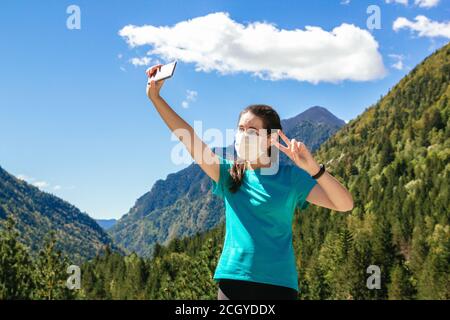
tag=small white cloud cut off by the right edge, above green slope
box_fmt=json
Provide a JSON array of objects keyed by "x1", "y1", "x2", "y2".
[{"x1": 392, "y1": 15, "x2": 450, "y2": 38}]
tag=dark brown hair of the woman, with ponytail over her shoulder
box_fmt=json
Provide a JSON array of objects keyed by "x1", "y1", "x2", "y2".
[{"x1": 229, "y1": 104, "x2": 282, "y2": 193}]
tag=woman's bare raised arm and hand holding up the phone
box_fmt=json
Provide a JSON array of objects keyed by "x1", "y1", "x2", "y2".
[{"x1": 147, "y1": 64, "x2": 220, "y2": 182}]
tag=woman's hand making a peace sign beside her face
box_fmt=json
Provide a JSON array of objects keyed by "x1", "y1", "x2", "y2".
[{"x1": 271, "y1": 130, "x2": 320, "y2": 176}]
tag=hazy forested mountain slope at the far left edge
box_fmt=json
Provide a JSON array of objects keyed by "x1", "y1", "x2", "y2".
[{"x1": 0, "y1": 167, "x2": 116, "y2": 263}]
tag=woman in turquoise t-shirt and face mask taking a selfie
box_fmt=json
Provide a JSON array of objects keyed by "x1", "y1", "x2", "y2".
[{"x1": 147, "y1": 64, "x2": 353, "y2": 300}]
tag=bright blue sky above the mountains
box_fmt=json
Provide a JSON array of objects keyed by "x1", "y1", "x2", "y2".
[{"x1": 0, "y1": 0, "x2": 450, "y2": 218}]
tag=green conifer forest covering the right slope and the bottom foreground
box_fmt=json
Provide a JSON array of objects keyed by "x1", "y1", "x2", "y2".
[{"x1": 0, "y1": 44, "x2": 450, "y2": 300}]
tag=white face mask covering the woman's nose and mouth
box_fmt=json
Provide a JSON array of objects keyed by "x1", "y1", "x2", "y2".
[{"x1": 234, "y1": 130, "x2": 268, "y2": 162}]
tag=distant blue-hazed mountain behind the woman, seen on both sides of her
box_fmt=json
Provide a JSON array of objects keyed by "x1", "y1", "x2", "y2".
[{"x1": 108, "y1": 106, "x2": 345, "y2": 256}]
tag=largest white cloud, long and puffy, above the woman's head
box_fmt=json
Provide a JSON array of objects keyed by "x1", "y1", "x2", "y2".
[{"x1": 119, "y1": 12, "x2": 386, "y2": 83}]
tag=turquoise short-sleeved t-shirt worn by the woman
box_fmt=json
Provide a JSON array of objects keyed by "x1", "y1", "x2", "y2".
[{"x1": 212, "y1": 156, "x2": 317, "y2": 291}]
